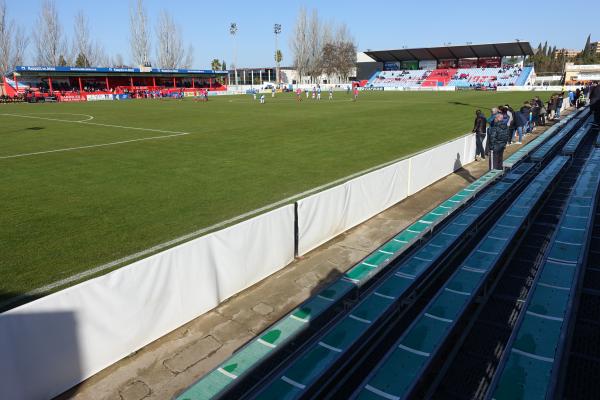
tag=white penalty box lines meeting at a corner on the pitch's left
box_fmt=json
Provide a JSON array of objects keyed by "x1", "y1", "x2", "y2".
[{"x1": 0, "y1": 113, "x2": 192, "y2": 160}]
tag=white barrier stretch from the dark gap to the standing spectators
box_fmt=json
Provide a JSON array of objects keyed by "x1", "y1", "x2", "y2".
[{"x1": 297, "y1": 134, "x2": 475, "y2": 255}]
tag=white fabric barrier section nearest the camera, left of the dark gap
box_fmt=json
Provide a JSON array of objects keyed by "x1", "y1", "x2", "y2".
[{"x1": 0, "y1": 205, "x2": 294, "y2": 400}]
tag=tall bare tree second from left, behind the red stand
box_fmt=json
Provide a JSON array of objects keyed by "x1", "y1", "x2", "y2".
[{"x1": 33, "y1": 0, "x2": 67, "y2": 65}]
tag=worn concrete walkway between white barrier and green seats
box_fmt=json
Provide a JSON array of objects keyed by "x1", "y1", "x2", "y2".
[{"x1": 59, "y1": 121, "x2": 560, "y2": 400}]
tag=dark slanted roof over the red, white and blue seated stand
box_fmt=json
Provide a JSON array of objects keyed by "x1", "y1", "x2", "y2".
[{"x1": 365, "y1": 42, "x2": 533, "y2": 62}]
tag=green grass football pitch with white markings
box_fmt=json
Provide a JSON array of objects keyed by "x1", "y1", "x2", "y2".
[{"x1": 0, "y1": 91, "x2": 532, "y2": 303}]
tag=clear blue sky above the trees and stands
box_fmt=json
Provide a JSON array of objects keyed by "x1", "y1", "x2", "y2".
[{"x1": 6, "y1": 0, "x2": 600, "y2": 68}]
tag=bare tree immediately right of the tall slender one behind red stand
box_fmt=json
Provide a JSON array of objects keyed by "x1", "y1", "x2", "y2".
[{"x1": 156, "y1": 10, "x2": 184, "y2": 69}]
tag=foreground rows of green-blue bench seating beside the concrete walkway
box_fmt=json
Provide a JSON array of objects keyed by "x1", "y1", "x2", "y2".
[{"x1": 178, "y1": 106, "x2": 600, "y2": 400}]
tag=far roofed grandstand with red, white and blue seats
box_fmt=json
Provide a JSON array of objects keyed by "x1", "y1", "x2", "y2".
[{"x1": 359, "y1": 42, "x2": 534, "y2": 88}]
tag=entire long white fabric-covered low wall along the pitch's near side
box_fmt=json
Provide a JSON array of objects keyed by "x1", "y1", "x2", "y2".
[{"x1": 0, "y1": 130, "x2": 475, "y2": 400}]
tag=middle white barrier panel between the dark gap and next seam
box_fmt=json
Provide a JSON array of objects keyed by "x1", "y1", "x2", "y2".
[{"x1": 297, "y1": 160, "x2": 408, "y2": 255}]
